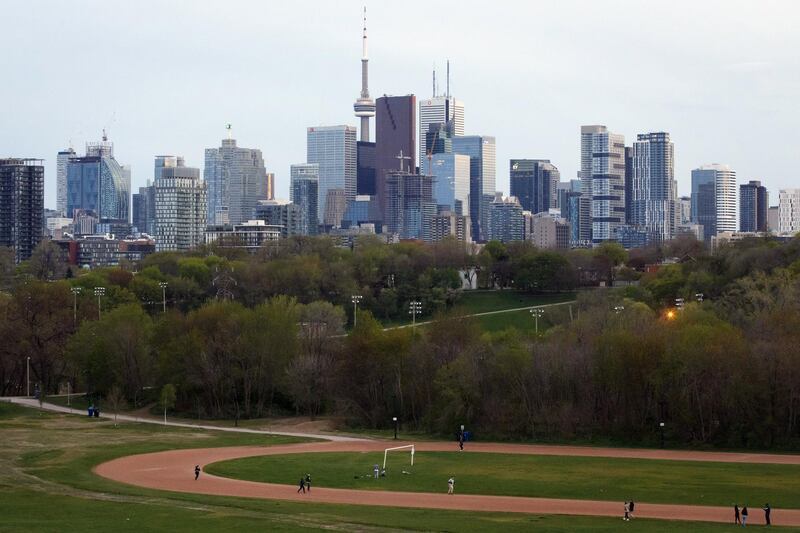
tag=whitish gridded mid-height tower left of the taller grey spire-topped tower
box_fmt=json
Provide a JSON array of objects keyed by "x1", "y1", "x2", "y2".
[{"x1": 153, "y1": 156, "x2": 208, "y2": 251}]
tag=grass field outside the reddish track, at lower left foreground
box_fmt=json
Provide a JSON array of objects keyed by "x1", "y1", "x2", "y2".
[{"x1": 0, "y1": 402, "x2": 788, "y2": 533}]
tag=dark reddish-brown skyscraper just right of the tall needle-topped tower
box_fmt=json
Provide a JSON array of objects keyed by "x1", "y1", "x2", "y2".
[{"x1": 375, "y1": 94, "x2": 417, "y2": 217}]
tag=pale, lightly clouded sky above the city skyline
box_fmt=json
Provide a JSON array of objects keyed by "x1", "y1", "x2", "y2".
[{"x1": 0, "y1": 0, "x2": 800, "y2": 207}]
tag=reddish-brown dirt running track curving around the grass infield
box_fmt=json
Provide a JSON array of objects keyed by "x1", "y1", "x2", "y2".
[{"x1": 95, "y1": 441, "x2": 800, "y2": 526}]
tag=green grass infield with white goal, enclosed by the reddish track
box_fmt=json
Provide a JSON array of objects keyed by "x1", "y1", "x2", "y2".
[{"x1": 206, "y1": 451, "x2": 800, "y2": 508}]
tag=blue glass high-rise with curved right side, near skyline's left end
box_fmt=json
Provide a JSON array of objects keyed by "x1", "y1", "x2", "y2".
[{"x1": 67, "y1": 132, "x2": 131, "y2": 223}]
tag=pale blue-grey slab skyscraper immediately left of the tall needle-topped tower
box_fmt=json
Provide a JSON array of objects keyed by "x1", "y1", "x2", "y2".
[{"x1": 306, "y1": 126, "x2": 356, "y2": 222}]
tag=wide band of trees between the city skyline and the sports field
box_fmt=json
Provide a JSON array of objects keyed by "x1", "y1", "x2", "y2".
[{"x1": 0, "y1": 235, "x2": 800, "y2": 448}]
